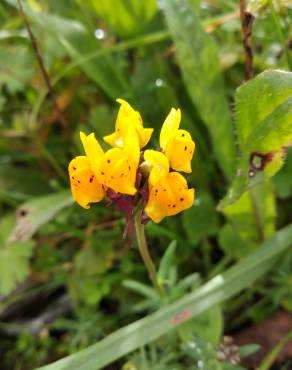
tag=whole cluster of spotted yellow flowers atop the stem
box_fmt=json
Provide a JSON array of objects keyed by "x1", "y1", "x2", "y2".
[{"x1": 68, "y1": 99, "x2": 195, "y2": 223}]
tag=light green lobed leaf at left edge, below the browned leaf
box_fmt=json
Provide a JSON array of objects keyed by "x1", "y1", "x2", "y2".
[{"x1": 0, "y1": 216, "x2": 34, "y2": 295}]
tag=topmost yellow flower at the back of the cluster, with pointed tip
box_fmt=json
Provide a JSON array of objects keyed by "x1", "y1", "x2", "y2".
[{"x1": 103, "y1": 99, "x2": 153, "y2": 148}]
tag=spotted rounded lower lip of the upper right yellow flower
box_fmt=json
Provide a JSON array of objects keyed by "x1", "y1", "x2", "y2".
[{"x1": 165, "y1": 130, "x2": 195, "y2": 173}]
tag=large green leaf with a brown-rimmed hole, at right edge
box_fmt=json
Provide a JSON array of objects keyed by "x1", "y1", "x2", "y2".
[{"x1": 219, "y1": 71, "x2": 292, "y2": 209}]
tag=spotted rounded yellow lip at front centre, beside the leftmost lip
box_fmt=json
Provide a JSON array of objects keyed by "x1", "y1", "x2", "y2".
[{"x1": 98, "y1": 148, "x2": 137, "y2": 195}]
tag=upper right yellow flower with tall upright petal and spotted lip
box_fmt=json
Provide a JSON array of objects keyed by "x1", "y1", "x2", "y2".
[{"x1": 159, "y1": 108, "x2": 195, "y2": 173}]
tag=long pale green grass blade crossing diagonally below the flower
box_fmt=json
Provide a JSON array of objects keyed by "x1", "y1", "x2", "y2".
[{"x1": 35, "y1": 225, "x2": 292, "y2": 370}]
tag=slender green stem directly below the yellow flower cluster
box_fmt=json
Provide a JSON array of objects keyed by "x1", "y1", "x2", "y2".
[{"x1": 135, "y1": 212, "x2": 165, "y2": 297}]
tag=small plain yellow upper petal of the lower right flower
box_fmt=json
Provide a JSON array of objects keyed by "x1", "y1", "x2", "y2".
[{"x1": 144, "y1": 149, "x2": 169, "y2": 189}]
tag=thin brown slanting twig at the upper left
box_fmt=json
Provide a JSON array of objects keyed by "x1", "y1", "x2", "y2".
[{"x1": 17, "y1": 0, "x2": 68, "y2": 127}]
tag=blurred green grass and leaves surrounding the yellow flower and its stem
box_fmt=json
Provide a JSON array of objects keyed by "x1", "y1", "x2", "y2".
[{"x1": 0, "y1": 0, "x2": 292, "y2": 370}]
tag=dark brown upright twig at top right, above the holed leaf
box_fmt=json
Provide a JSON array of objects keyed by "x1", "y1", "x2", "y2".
[{"x1": 239, "y1": 0, "x2": 254, "y2": 80}]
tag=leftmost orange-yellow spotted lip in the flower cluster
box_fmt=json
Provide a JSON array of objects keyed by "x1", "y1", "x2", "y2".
[{"x1": 68, "y1": 156, "x2": 105, "y2": 208}]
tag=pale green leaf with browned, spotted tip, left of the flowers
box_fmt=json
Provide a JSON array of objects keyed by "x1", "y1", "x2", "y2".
[{"x1": 11, "y1": 190, "x2": 73, "y2": 240}]
